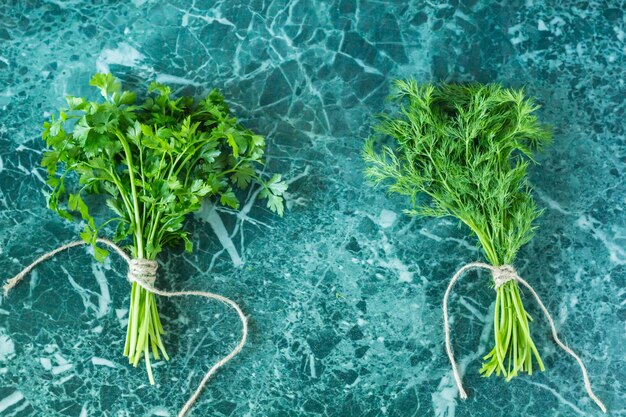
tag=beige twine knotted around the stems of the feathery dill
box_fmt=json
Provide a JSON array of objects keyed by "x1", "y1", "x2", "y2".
[{"x1": 443, "y1": 262, "x2": 606, "y2": 413}]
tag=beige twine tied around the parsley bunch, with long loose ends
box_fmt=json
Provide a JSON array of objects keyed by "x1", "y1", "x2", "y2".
[{"x1": 4, "y1": 238, "x2": 248, "y2": 417}]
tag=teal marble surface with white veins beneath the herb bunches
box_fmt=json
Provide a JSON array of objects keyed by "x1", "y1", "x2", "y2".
[{"x1": 0, "y1": 0, "x2": 626, "y2": 417}]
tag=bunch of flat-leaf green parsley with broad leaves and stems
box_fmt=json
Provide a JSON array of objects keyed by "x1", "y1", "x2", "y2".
[{"x1": 42, "y1": 74, "x2": 287, "y2": 383}]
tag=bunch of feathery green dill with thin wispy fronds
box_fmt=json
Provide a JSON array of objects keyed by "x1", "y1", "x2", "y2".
[{"x1": 363, "y1": 80, "x2": 550, "y2": 380}]
